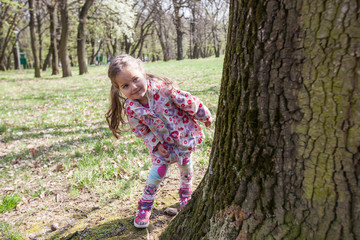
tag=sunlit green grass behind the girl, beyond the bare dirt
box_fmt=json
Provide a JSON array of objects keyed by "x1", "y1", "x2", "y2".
[{"x1": 0, "y1": 58, "x2": 223, "y2": 204}]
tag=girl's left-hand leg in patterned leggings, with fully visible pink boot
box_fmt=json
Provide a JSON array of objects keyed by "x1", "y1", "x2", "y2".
[{"x1": 134, "y1": 159, "x2": 168, "y2": 228}]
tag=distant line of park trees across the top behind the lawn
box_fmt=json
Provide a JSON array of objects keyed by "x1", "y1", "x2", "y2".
[{"x1": 0, "y1": 0, "x2": 228, "y2": 77}]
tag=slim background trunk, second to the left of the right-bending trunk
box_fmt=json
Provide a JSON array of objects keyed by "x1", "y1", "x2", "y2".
[{"x1": 47, "y1": 1, "x2": 59, "y2": 75}]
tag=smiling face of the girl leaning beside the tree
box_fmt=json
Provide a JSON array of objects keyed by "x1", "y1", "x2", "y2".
[{"x1": 115, "y1": 64, "x2": 148, "y2": 104}]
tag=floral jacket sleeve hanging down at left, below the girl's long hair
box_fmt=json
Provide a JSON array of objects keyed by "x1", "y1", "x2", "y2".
[{"x1": 126, "y1": 109, "x2": 160, "y2": 152}]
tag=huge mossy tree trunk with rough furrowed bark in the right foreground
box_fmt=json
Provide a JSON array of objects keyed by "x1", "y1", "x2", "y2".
[{"x1": 161, "y1": 0, "x2": 360, "y2": 239}]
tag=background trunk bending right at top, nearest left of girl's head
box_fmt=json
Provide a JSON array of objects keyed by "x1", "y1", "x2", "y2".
[{"x1": 77, "y1": 0, "x2": 95, "y2": 75}]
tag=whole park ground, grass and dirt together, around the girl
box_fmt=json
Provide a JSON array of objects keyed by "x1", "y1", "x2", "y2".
[{"x1": 0, "y1": 58, "x2": 223, "y2": 239}]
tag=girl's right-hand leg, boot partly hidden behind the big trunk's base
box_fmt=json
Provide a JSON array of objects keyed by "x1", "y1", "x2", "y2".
[{"x1": 178, "y1": 157, "x2": 193, "y2": 210}]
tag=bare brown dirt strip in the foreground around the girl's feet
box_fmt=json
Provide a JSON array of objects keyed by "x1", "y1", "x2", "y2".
[{"x1": 0, "y1": 158, "x2": 205, "y2": 239}]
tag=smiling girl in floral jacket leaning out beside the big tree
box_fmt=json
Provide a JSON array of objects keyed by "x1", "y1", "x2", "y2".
[{"x1": 106, "y1": 54, "x2": 212, "y2": 228}]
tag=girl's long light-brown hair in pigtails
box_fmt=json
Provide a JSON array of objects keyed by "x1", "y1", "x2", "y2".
[{"x1": 105, "y1": 54, "x2": 175, "y2": 138}]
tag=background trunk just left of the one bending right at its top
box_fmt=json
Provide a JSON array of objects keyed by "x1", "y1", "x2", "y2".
[{"x1": 59, "y1": 0, "x2": 72, "y2": 77}]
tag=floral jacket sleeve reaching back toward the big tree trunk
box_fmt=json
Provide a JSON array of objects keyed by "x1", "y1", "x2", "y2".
[{"x1": 171, "y1": 89, "x2": 211, "y2": 122}]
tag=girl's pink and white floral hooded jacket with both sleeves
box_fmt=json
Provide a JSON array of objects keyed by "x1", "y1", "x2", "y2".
[{"x1": 125, "y1": 79, "x2": 211, "y2": 153}]
